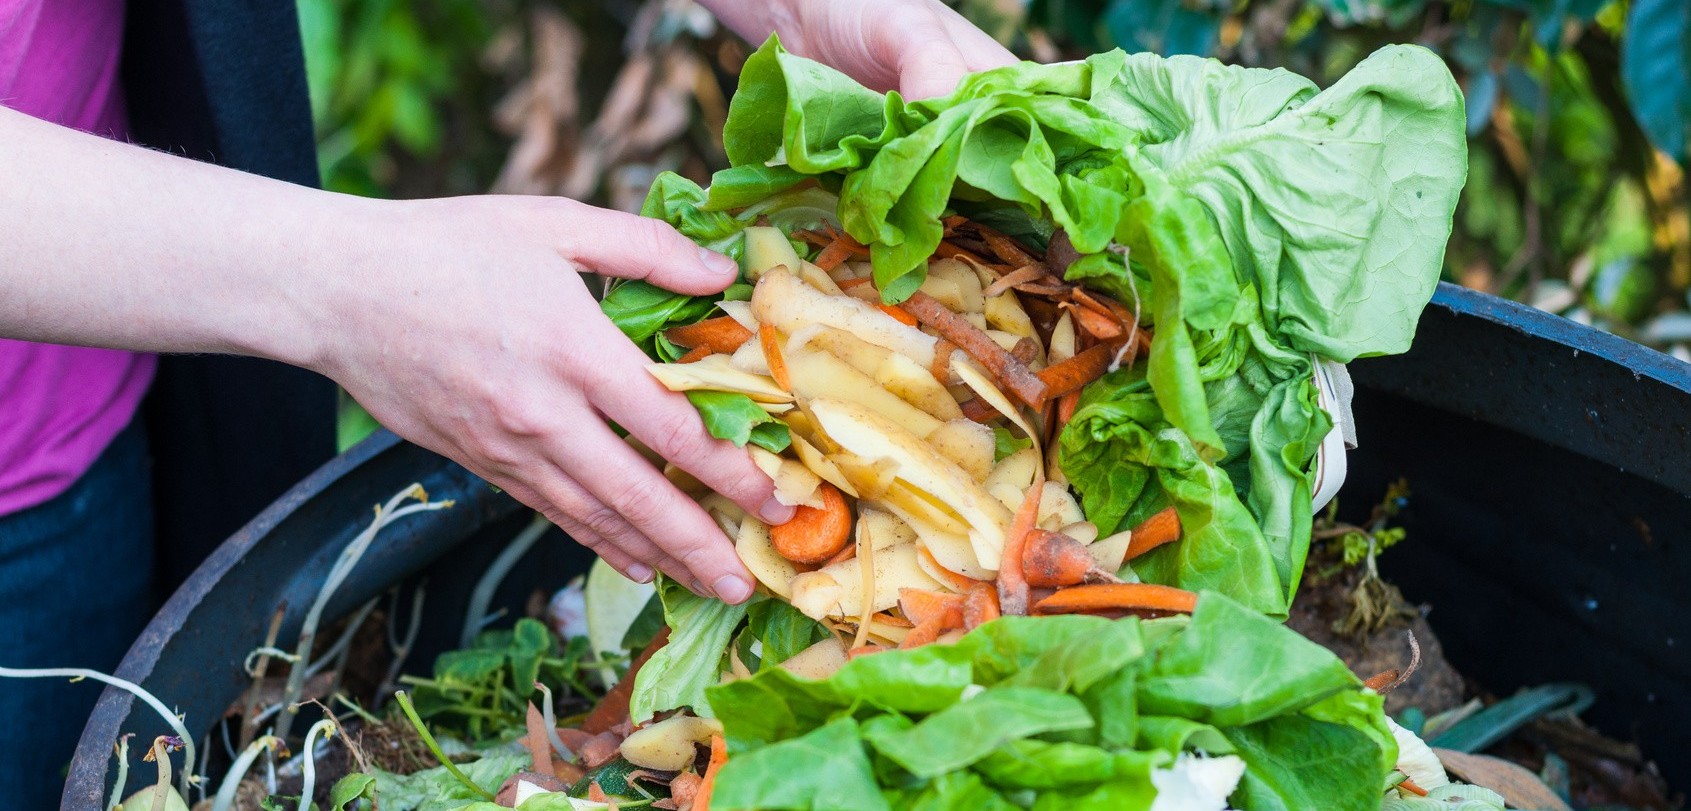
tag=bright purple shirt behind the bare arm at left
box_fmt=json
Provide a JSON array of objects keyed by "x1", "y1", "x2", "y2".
[{"x1": 0, "y1": 0, "x2": 156, "y2": 515}]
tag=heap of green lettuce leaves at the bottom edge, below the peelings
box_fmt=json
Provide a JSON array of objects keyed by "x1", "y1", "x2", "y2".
[{"x1": 707, "y1": 593, "x2": 1397, "y2": 811}]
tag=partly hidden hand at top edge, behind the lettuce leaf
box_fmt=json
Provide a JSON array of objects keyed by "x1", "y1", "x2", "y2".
[{"x1": 703, "y1": 0, "x2": 1016, "y2": 98}]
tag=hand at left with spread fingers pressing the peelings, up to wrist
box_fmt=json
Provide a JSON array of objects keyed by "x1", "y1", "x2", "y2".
[{"x1": 313, "y1": 196, "x2": 793, "y2": 603}]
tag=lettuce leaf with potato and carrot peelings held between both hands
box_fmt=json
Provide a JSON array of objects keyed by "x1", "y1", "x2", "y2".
[{"x1": 604, "y1": 34, "x2": 1466, "y2": 617}]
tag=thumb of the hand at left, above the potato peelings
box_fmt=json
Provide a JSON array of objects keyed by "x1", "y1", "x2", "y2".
[{"x1": 558, "y1": 206, "x2": 739, "y2": 296}]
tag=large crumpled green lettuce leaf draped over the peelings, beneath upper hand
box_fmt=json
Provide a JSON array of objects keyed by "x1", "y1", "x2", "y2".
[{"x1": 714, "y1": 39, "x2": 1466, "y2": 615}]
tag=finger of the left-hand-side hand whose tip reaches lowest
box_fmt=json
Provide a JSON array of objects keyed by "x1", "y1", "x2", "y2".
[{"x1": 548, "y1": 424, "x2": 752, "y2": 603}]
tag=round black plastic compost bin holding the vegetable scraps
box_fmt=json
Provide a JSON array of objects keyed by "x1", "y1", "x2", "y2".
[{"x1": 63, "y1": 284, "x2": 1691, "y2": 809}]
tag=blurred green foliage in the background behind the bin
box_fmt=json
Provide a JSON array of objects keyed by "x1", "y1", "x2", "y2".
[{"x1": 298, "y1": 0, "x2": 1691, "y2": 358}]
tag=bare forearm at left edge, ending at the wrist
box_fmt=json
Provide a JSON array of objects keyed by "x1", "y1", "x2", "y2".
[{"x1": 0, "y1": 108, "x2": 356, "y2": 365}]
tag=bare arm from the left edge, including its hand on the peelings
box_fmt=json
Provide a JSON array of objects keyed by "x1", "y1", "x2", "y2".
[{"x1": 0, "y1": 108, "x2": 791, "y2": 601}]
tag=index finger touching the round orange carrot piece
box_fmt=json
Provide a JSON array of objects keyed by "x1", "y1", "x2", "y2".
[{"x1": 587, "y1": 332, "x2": 793, "y2": 524}]
